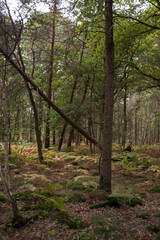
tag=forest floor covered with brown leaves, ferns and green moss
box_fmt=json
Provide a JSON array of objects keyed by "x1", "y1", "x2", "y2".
[{"x1": 0, "y1": 144, "x2": 160, "y2": 240}]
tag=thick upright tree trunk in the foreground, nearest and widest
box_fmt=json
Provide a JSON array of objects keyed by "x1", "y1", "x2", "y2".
[{"x1": 99, "y1": 0, "x2": 114, "y2": 193}]
